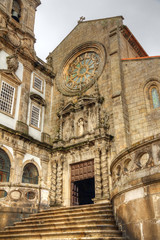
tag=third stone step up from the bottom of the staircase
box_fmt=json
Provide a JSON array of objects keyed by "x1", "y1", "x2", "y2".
[{"x1": 5, "y1": 219, "x2": 115, "y2": 230}]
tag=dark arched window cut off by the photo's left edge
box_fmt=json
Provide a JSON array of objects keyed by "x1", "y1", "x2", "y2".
[{"x1": 0, "y1": 149, "x2": 10, "y2": 182}]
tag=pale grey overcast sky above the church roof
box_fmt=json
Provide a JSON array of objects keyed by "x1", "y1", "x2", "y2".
[{"x1": 35, "y1": 0, "x2": 160, "y2": 60}]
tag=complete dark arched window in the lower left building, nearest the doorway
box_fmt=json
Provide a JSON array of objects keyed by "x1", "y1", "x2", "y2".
[{"x1": 22, "y1": 163, "x2": 38, "y2": 184}]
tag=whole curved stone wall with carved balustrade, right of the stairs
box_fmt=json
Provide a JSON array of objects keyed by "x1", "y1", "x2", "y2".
[{"x1": 111, "y1": 136, "x2": 160, "y2": 240}]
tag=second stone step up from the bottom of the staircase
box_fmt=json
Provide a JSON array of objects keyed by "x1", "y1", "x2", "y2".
[{"x1": 0, "y1": 224, "x2": 118, "y2": 235}]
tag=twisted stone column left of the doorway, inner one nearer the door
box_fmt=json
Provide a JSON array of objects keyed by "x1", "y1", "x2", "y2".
[{"x1": 56, "y1": 158, "x2": 63, "y2": 205}]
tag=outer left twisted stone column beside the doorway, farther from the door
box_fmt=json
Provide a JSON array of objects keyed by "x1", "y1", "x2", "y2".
[{"x1": 50, "y1": 161, "x2": 57, "y2": 206}]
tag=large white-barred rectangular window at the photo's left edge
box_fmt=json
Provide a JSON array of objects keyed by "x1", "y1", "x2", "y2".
[{"x1": 0, "y1": 82, "x2": 15, "y2": 114}]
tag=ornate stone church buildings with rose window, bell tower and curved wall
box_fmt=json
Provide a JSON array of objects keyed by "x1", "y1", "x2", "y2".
[{"x1": 0, "y1": 0, "x2": 160, "y2": 240}]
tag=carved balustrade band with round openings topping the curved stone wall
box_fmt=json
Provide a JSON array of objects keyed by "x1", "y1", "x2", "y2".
[{"x1": 111, "y1": 136, "x2": 160, "y2": 198}]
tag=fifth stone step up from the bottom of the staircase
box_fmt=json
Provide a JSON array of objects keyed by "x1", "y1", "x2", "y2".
[{"x1": 22, "y1": 210, "x2": 113, "y2": 221}]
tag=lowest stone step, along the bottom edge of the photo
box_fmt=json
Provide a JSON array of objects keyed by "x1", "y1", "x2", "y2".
[{"x1": 0, "y1": 230, "x2": 123, "y2": 240}]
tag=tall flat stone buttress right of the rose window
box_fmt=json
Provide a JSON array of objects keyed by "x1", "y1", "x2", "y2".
[{"x1": 109, "y1": 22, "x2": 130, "y2": 153}]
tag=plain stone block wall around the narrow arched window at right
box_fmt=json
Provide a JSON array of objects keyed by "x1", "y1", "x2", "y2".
[{"x1": 123, "y1": 57, "x2": 160, "y2": 144}]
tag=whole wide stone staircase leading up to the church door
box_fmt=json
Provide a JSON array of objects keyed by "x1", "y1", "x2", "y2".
[{"x1": 0, "y1": 203, "x2": 125, "y2": 240}]
